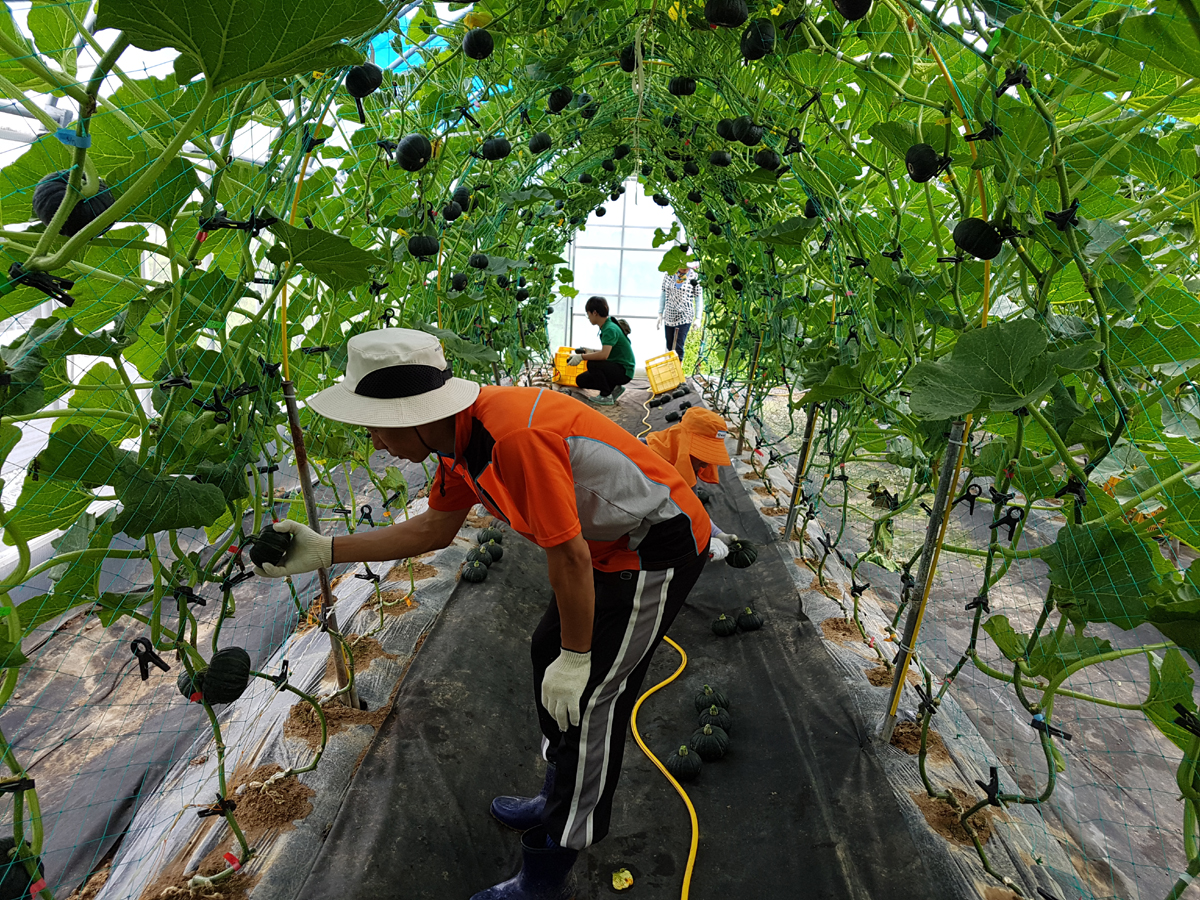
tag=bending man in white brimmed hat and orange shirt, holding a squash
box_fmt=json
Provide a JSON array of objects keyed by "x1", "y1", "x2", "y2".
[{"x1": 254, "y1": 329, "x2": 710, "y2": 900}]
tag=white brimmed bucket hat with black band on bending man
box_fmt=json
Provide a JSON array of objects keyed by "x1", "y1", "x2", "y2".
[{"x1": 305, "y1": 328, "x2": 479, "y2": 428}]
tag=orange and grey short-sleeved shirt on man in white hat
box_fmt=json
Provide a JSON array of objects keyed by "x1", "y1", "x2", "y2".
[{"x1": 430, "y1": 386, "x2": 712, "y2": 572}]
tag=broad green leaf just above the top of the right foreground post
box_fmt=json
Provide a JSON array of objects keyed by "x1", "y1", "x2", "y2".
[{"x1": 908, "y1": 319, "x2": 1058, "y2": 419}]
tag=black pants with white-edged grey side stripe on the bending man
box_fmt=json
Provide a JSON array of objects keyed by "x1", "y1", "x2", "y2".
[{"x1": 532, "y1": 548, "x2": 708, "y2": 850}]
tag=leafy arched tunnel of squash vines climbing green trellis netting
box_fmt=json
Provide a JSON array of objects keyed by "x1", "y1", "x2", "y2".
[{"x1": 0, "y1": 0, "x2": 1200, "y2": 898}]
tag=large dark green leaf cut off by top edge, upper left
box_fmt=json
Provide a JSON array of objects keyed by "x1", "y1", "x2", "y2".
[{"x1": 96, "y1": 0, "x2": 386, "y2": 89}]
